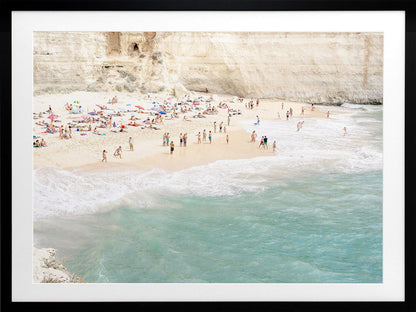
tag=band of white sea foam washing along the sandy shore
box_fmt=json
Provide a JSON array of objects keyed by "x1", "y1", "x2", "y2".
[{"x1": 33, "y1": 107, "x2": 382, "y2": 220}]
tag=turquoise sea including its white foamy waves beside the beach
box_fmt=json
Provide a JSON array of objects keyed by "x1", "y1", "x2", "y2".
[{"x1": 34, "y1": 105, "x2": 383, "y2": 283}]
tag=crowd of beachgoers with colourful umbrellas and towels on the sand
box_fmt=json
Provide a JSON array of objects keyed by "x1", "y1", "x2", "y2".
[{"x1": 33, "y1": 94, "x2": 332, "y2": 169}]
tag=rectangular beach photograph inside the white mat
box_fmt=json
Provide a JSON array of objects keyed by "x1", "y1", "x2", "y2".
[{"x1": 32, "y1": 31, "x2": 384, "y2": 283}]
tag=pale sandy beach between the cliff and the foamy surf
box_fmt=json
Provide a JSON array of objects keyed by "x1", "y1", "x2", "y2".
[{"x1": 33, "y1": 92, "x2": 326, "y2": 171}]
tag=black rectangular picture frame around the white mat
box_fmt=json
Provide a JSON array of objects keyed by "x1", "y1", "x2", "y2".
[{"x1": 0, "y1": 0, "x2": 416, "y2": 311}]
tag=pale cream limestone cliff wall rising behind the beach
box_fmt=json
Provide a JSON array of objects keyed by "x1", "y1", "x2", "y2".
[{"x1": 33, "y1": 32, "x2": 383, "y2": 104}]
